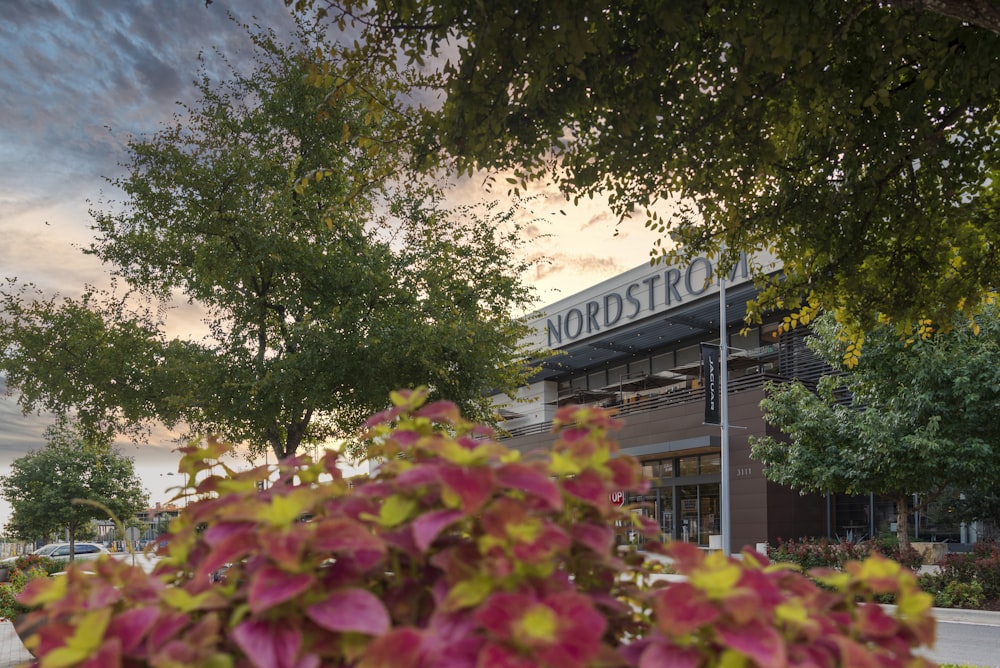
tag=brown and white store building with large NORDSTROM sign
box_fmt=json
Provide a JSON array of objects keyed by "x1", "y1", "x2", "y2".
[{"x1": 497, "y1": 256, "x2": 856, "y2": 550}]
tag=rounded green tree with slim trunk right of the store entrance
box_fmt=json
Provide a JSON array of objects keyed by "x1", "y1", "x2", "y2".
[{"x1": 751, "y1": 304, "x2": 1000, "y2": 548}]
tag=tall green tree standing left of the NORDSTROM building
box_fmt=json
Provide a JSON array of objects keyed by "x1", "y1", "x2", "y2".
[{"x1": 0, "y1": 18, "x2": 532, "y2": 459}]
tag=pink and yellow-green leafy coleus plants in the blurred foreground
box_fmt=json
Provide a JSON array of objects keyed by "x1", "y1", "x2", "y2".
[{"x1": 23, "y1": 392, "x2": 934, "y2": 668}]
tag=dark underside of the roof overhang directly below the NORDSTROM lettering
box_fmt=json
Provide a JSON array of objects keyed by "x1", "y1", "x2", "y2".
[{"x1": 532, "y1": 283, "x2": 757, "y2": 381}]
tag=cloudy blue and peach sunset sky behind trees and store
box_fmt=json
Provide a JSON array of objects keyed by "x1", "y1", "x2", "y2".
[{"x1": 0, "y1": 0, "x2": 654, "y2": 528}]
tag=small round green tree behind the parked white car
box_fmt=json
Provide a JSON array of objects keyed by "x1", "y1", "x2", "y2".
[{"x1": 0, "y1": 419, "x2": 149, "y2": 558}]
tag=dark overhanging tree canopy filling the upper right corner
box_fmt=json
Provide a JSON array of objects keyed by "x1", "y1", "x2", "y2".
[{"x1": 285, "y1": 0, "x2": 1000, "y2": 331}]
